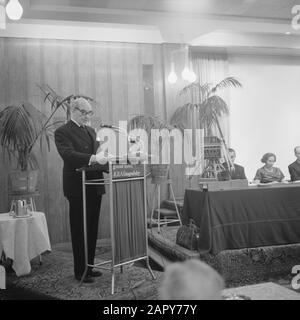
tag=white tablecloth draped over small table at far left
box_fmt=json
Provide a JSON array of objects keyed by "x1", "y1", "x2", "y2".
[{"x1": 0, "y1": 212, "x2": 51, "y2": 276}]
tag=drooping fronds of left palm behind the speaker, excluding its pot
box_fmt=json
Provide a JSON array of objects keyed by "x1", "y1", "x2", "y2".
[{"x1": 0, "y1": 85, "x2": 93, "y2": 170}]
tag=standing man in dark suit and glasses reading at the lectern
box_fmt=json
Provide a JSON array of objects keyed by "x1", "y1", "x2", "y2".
[{"x1": 55, "y1": 98, "x2": 108, "y2": 283}]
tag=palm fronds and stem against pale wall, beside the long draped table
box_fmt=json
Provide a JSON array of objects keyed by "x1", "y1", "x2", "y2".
[{"x1": 171, "y1": 77, "x2": 242, "y2": 179}]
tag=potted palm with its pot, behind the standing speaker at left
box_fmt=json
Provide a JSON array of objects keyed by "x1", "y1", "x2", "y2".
[{"x1": 0, "y1": 90, "x2": 73, "y2": 193}]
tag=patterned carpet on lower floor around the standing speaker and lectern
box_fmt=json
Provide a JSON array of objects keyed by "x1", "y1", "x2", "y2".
[{"x1": 2, "y1": 243, "x2": 161, "y2": 300}]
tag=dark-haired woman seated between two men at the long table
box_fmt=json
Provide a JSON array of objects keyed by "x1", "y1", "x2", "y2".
[{"x1": 254, "y1": 153, "x2": 284, "y2": 183}]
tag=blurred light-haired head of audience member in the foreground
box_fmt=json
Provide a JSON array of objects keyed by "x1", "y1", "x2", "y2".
[{"x1": 160, "y1": 259, "x2": 224, "y2": 300}]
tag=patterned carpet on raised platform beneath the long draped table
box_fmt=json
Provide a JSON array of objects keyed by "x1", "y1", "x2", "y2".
[{"x1": 148, "y1": 227, "x2": 300, "y2": 287}]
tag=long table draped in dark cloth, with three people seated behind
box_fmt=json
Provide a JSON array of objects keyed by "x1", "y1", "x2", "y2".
[{"x1": 182, "y1": 183, "x2": 300, "y2": 254}]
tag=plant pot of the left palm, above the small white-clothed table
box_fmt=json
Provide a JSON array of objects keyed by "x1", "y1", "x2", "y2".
[{"x1": 8, "y1": 170, "x2": 38, "y2": 193}]
